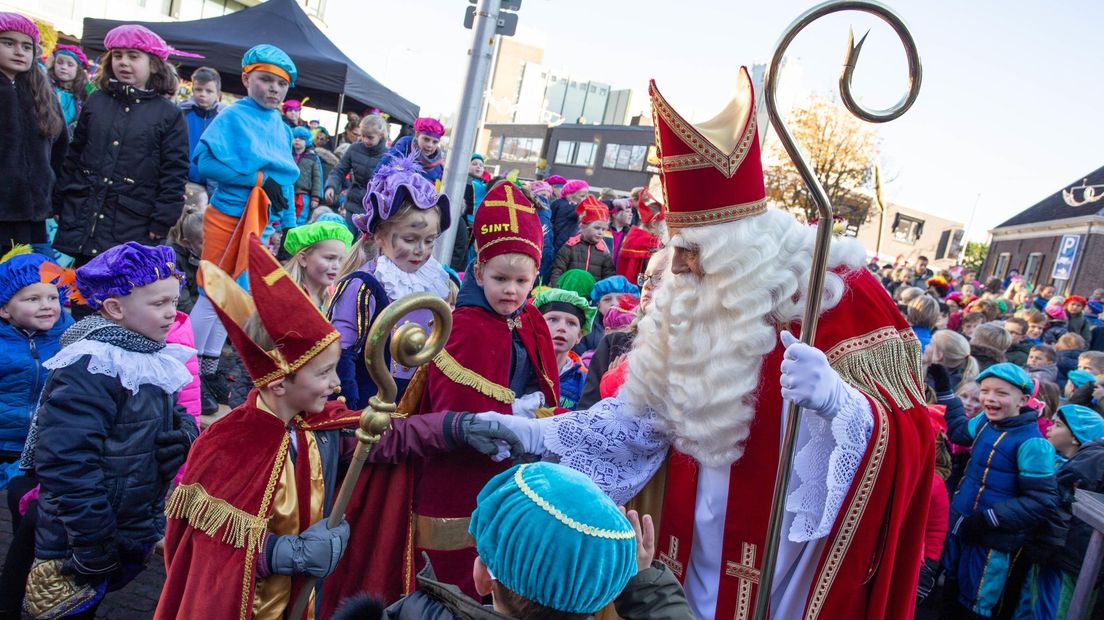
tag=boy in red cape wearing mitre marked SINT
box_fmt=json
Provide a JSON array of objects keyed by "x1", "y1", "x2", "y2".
[{"x1": 407, "y1": 181, "x2": 560, "y2": 597}]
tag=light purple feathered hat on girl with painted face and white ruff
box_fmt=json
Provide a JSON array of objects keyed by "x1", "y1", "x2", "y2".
[{"x1": 352, "y1": 151, "x2": 450, "y2": 234}]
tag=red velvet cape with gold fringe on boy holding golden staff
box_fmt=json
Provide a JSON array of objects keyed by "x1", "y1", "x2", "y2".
[{"x1": 155, "y1": 391, "x2": 359, "y2": 620}]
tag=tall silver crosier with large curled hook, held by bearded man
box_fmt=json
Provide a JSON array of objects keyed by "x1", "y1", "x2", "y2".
[{"x1": 755, "y1": 0, "x2": 922, "y2": 620}]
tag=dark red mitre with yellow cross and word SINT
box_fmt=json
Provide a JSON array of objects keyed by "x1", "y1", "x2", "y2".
[{"x1": 473, "y1": 181, "x2": 544, "y2": 265}]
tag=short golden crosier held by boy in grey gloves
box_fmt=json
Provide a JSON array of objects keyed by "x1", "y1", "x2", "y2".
[{"x1": 287, "y1": 292, "x2": 453, "y2": 619}]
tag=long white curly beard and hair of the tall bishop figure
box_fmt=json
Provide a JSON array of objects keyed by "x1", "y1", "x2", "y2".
[{"x1": 619, "y1": 210, "x2": 866, "y2": 467}]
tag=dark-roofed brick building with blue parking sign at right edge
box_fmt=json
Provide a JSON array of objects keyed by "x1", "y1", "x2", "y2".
[{"x1": 981, "y1": 168, "x2": 1104, "y2": 296}]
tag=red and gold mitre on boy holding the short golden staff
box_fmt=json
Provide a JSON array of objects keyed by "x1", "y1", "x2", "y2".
[{"x1": 200, "y1": 235, "x2": 338, "y2": 387}]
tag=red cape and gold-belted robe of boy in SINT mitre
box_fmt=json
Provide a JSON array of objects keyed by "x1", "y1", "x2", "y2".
[{"x1": 414, "y1": 303, "x2": 560, "y2": 597}]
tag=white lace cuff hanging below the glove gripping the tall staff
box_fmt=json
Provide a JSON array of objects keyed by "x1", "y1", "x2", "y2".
[{"x1": 786, "y1": 385, "x2": 874, "y2": 543}]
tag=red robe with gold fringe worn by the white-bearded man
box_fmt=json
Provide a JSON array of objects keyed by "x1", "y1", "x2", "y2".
[{"x1": 656, "y1": 269, "x2": 935, "y2": 620}]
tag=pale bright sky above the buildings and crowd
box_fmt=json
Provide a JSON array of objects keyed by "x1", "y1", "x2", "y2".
[{"x1": 327, "y1": 0, "x2": 1104, "y2": 239}]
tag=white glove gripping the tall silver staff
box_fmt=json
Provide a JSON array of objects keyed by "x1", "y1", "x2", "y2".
[{"x1": 779, "y1": 331, "x2": 847, "y2": 416}]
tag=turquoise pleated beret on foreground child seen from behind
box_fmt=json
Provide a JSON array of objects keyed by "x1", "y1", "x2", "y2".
[{"x1": 468, "y1": 462, "x2": 636, "y2": 613}]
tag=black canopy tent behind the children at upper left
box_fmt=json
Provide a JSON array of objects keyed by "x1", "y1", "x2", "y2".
[{"x1": 81, "y1": 0, "x2": 418, "y2": 125}]
